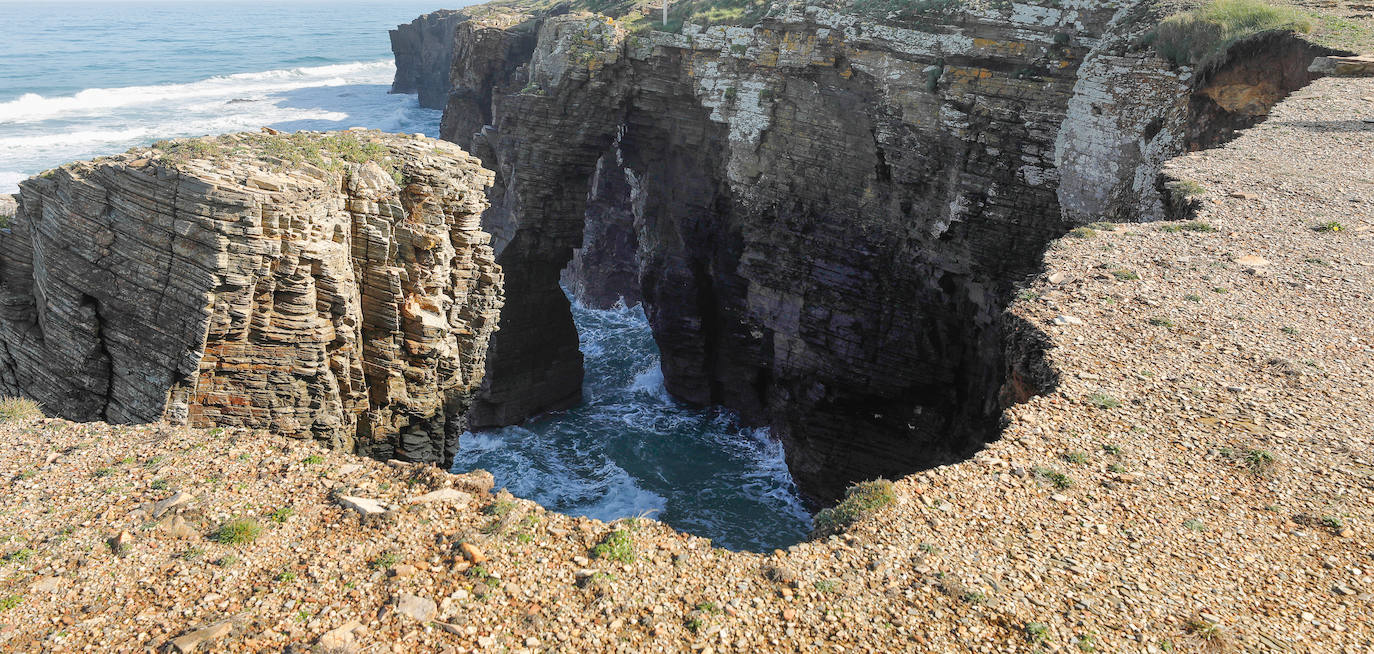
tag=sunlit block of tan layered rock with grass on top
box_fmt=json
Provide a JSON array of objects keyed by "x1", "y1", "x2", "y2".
[{"x1": 0, "y1": 132, "x2": 502, "y2": 464}]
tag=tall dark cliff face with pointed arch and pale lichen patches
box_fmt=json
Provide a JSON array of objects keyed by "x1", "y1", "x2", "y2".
[{"x1": 401, "y1": 3, "x2": 1341, "y2": 499}]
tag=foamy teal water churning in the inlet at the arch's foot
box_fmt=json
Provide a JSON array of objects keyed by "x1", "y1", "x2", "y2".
[{"x1": 453, "y1": 298, "x2": 811, "y2": 551}]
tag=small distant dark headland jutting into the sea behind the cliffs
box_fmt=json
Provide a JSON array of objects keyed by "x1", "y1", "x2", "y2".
[{"x1": 390, "y1": 10, "x2": 467, "y2": 109}]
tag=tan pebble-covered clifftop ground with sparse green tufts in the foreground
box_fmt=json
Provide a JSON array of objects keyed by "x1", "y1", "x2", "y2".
[{"x1": 0, "y1": 80, "x2": 1374, "y2": 654}]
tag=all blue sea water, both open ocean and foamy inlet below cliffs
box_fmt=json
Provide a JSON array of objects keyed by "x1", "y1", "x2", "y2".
[{"x1": 0, "y1": 0, "x2": 811, "y2": 551}]
